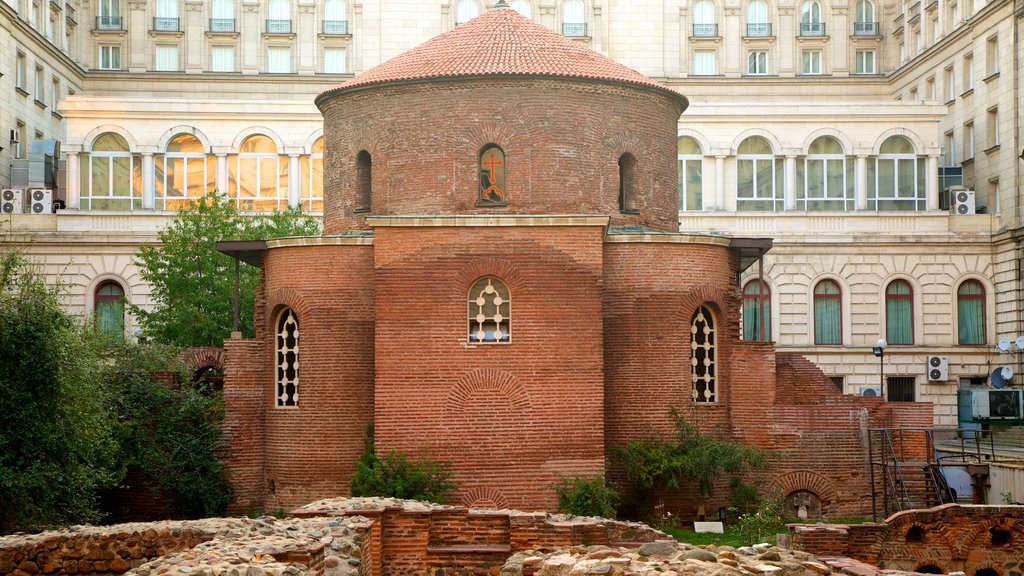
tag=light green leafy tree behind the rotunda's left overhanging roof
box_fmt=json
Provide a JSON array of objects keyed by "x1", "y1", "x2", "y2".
[{"x1": 131, "y1": 193, "x2": 321, "y2": 346}]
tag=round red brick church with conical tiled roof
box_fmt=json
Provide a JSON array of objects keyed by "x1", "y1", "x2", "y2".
[{"x1": 222, "y1": 3, "x2": 932, "y2": 513}]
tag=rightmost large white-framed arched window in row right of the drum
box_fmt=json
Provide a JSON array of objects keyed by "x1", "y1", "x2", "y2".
[{"x1": 867, "y1": 136, "x2": 927, "y2": 210}]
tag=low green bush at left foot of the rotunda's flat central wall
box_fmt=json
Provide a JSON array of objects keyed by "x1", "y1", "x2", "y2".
[{"x1": 351, "y1": 427, "x2": 456, "y2": 504}]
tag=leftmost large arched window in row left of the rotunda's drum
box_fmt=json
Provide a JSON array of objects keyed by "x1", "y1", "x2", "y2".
[{"x1": 81, "y1": 132, "x2": 142, "y2": 210}]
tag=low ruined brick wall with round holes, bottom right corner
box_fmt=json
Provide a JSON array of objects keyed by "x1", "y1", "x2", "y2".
[{"x1": 790, "y1": 504, "x2": 1024, "y2": 576}]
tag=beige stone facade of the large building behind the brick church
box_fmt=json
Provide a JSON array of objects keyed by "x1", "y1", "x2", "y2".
[{"x1": 0, "y1": 0, "x2": 1024, "y2": 425}]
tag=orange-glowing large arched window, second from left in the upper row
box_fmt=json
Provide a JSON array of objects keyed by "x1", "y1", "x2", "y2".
[{"x1": 153, "y1": 134, "x2": 211, "y2": 210}]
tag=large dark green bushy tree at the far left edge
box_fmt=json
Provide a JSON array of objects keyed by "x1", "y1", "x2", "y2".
[{"x1": 0, "y1": 251, "x2": 116, "y2": 534}]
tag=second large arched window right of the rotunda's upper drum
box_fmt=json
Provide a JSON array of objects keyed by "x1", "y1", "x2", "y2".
[{"x1": 736, "y1": 136, "x2": 785, "y2": 211}]
